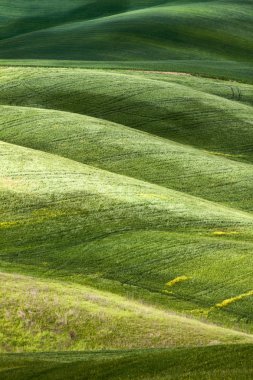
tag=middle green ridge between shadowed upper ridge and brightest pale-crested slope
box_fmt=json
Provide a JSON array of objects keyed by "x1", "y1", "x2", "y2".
[{"x1": 0, "y1": 106, "x2": 253, "y2": 212}]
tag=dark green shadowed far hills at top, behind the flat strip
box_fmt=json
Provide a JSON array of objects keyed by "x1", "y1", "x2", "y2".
[{"x1": 0, "y1": 0, "x2": 253, "y2": 62}]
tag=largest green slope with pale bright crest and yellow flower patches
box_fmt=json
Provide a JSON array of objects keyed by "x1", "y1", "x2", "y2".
[{"x1": 0, "y1": 143, "x2": 253, "y2": 331}]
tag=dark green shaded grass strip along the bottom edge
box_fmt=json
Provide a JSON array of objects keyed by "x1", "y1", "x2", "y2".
[{"x1": 0, "y1": 345, "x2": 253, "y2": 380}]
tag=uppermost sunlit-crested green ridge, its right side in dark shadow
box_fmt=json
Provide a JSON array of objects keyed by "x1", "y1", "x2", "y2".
[{"x1": 0, "y1": 68, "x2": 253, "y2": 162}]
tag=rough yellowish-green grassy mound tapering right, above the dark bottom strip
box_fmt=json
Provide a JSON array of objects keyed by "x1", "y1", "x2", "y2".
[{"x1": 0, "y1": 273, "x2": 253, "y2": 352}]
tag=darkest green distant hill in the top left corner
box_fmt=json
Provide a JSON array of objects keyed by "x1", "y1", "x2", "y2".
[{"x1": 0, "y1": 0, "x2": 165, "y2": 39}]
